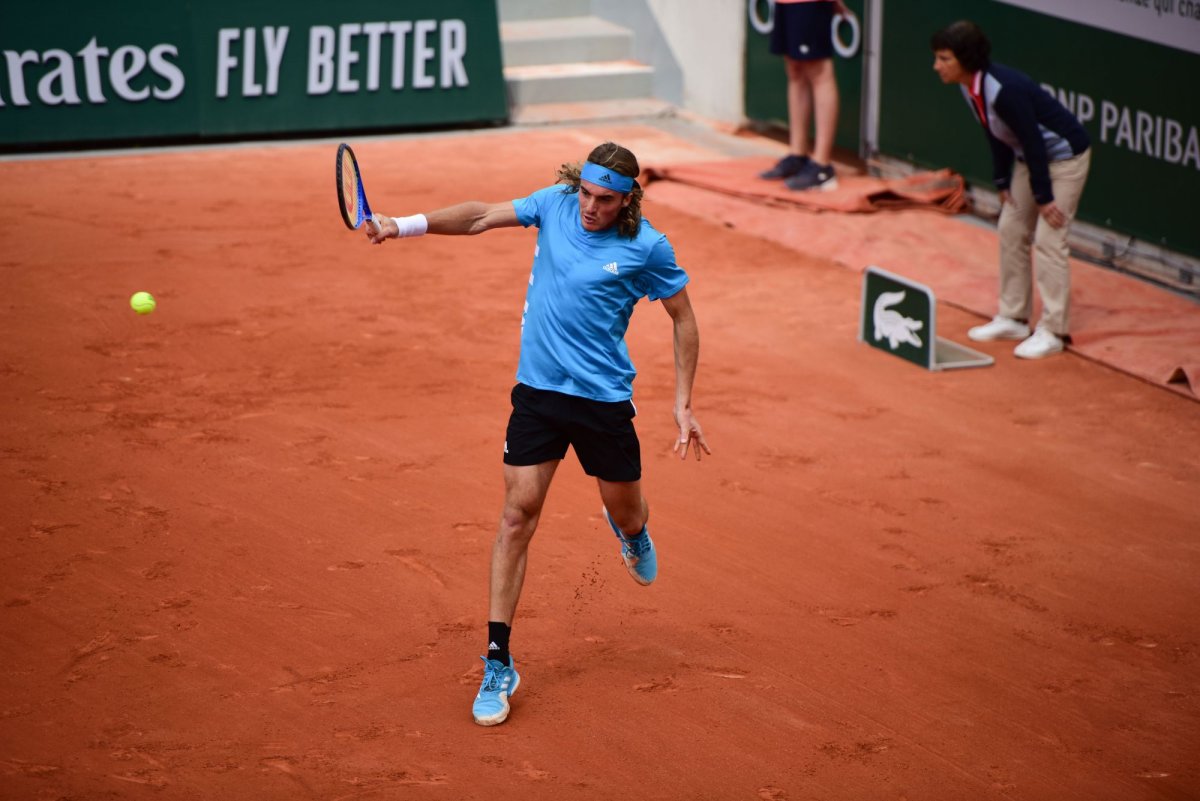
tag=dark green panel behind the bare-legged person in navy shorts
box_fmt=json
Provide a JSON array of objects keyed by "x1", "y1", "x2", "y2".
[{"x1": 745, "y1": 0, "x2": 866, "y2": 153}]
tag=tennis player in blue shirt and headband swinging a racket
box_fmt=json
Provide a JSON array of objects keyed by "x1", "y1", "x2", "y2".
[{"x1": 367, "y1": 141, "x2": 712, "y2": 725}]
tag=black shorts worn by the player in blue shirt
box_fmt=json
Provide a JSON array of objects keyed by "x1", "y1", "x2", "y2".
[{"x1": 504, "y1": 384, "x2": 642, "y2": 481}]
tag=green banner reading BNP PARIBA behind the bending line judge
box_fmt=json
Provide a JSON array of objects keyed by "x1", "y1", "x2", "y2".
[{"x1": 878, "y1": 0, "x2": 1200, "y2": 257}]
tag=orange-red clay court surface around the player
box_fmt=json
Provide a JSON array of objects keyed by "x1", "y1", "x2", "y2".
[{"x1": 0, "y1": 125, "x2": 1200, "y2": 801}]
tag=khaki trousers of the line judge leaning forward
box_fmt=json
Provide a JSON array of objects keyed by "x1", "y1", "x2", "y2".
[{"x1": 1000, "y1": 147, "x2": 1092, "y2": 337}]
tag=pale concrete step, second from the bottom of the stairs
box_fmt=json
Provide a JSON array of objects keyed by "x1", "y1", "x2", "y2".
[{"x1": 504, "y1": 60, "x2": 654, "y2": 107}]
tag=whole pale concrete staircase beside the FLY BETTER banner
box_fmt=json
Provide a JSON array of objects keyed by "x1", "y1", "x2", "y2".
[{"x1": 498, "y1": 0, "x2": 671, "y2": 124}]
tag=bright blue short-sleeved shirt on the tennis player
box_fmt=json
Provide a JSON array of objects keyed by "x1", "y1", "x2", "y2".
[{"x1": 512, "y1": 185, "x2": 688, "y2": 402}]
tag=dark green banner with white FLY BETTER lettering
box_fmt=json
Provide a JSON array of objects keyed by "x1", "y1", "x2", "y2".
[{"x1": 0, "y1": 0, "x2": 508, "y2": 150}]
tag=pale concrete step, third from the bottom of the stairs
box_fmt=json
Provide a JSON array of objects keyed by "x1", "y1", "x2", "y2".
[{"x1": 500, "y1": 17, "x2": 634, "y2": 67}]
